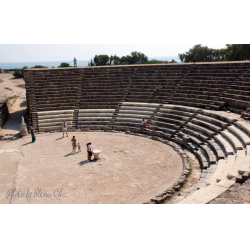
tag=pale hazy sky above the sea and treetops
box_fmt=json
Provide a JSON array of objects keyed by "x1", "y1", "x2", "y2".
[{"x1": 0, "y1": 44, "x2": 226, "y2": 62}]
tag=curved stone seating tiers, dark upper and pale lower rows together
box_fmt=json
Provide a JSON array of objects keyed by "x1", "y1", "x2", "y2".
[{"x1": 19, "y1": 61, "x2": 250, "y2": 204}]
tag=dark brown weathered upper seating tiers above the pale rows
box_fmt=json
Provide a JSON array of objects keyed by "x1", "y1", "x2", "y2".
[{"x1": 24, "y1": 61, "x2": 250, "y2": 127}]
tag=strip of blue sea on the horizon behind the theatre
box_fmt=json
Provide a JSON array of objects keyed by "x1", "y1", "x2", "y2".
[{"x1": 0, "y1": 56, "x2": 181, "y2": 69}]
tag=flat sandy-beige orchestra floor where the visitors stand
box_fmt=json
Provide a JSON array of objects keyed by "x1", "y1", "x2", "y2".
[{"x1": 0, "y1": 132, "x2": 183, "y2": 204}]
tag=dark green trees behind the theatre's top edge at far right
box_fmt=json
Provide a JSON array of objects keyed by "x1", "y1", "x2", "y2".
[{"x1": 178, "y1": 44, "x2": 250, "y2": 62}]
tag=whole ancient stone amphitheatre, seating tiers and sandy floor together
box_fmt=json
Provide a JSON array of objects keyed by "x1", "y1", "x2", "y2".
[{"x1": 0, "y1": 61, "x2": 250, "y2": 204}]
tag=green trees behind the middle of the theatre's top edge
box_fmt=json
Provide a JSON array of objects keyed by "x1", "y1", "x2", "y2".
[{"x1": 88, "y1": 51, "x2": 176, "y2": 66}]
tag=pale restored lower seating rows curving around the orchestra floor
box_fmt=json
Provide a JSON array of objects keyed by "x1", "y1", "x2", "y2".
[{"x1": 38, "y1": 102, "x2": 250, "y2": 204}]
